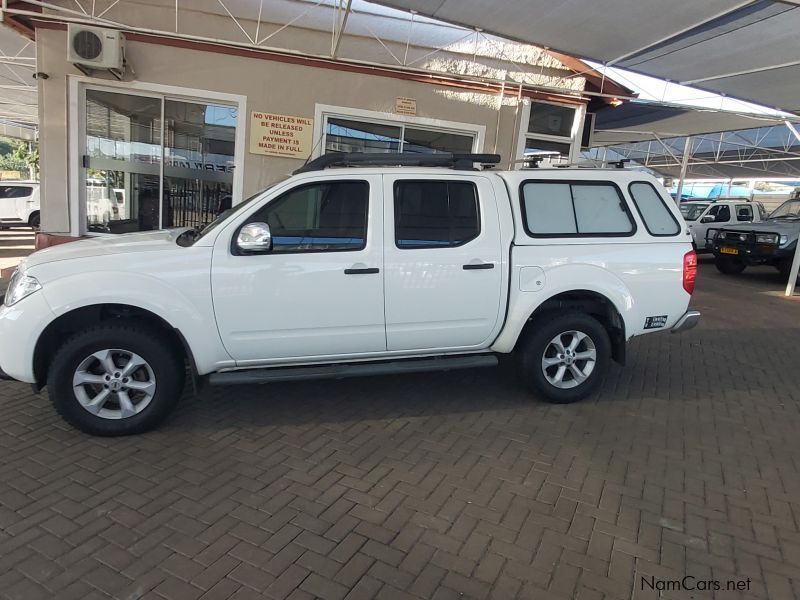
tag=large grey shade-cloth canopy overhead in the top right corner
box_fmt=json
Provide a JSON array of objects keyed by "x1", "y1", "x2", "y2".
[{"x1": 373, "y1": 0, "x2": 800, "y2": 114}]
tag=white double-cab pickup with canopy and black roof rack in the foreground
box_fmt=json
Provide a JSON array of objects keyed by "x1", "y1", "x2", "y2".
[{"x1": 0, "y1": 155, "x2": 699, "y2": 435}]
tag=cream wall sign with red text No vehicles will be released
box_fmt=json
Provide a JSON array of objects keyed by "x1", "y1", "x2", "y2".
[{"x1": 250, "y1": 111, "x2": 314, "y2": 160}]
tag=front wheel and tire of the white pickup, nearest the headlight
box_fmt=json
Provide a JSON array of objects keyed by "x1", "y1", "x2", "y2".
[{"x1": 47, "y1": 321, "x2": 186, "y2": 436}]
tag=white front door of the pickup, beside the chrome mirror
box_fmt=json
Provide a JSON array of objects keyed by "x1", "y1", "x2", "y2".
[{"x1": 211, "y1": 175, "x2": 386, "y2": 365}]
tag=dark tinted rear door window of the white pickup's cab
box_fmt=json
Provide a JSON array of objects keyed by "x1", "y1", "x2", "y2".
[{"x1": 394, "y1": 180, "x2": 481, "y2": 249}]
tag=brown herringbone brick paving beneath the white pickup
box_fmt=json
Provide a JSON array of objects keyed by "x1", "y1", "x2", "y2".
[{"x1": 0, "y1": 265, "x2": 800, "y2": 600}]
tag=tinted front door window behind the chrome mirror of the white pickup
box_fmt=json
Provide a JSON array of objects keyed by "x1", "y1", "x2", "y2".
[{"x1": 248, "y1": 181, "x2": 369, "y2": 253}]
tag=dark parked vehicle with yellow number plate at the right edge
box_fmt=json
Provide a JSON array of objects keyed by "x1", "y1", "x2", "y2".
[{"x1": 712, "y1": 193, "x2": 800, "y2": 278}]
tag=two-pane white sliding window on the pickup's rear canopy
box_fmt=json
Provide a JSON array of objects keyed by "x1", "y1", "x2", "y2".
[{"x1": 521, "y1": 181, "x2": 636, "y2": 237}]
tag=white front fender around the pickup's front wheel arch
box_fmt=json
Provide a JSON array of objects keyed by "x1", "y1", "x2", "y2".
[{"x1": 42, "y1": 270, "x2": 233, "y2": 375}]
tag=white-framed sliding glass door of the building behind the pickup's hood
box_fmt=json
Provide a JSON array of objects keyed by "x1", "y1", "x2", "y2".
[{"x1": 82, "y1": 88, "x2": 238, "y2": 233}]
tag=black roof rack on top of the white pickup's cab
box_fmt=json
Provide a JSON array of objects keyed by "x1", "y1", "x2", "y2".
[{"x1": 294, "y1": 152, "x2": 500, "y2": 175}]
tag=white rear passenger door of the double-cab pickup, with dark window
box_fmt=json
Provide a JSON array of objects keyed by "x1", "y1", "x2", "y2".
[{"x1": 384, "y1": 175, "x2": 502, "y2": 351}]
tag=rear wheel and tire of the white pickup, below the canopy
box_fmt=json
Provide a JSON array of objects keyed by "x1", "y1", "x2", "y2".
[{"x1": 519, "y1": 311, "x2": 611, "y2": 404}]
